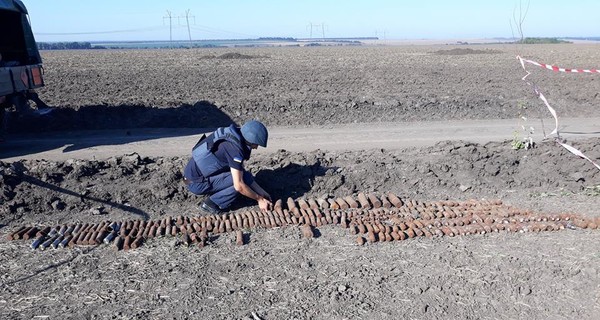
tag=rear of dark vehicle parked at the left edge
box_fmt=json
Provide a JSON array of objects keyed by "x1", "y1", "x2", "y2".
[{"x1": 0, "y1": 0, "x2": 52, "y2": 138}]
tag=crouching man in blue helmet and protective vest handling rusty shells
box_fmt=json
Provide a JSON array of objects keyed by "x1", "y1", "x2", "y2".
[{"x1": 183, "y1": 120, "x2": 272, "y2": 214}]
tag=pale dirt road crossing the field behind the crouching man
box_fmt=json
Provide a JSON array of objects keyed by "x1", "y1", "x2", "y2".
[{"x1": 0, "y1": 118, "x2": 600, "y2": 161}]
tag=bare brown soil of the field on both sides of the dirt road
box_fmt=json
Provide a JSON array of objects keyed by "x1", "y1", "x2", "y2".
[{"x1": 0, "y1": 45, "x2": 600, "y2": 319}]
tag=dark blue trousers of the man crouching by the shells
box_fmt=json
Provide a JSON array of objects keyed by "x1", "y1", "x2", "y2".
[{"x1": 188, "y1": 171, "x2": 254, "y2": 209}]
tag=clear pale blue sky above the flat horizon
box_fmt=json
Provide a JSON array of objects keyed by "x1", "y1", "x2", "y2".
[{"x1": 23, "y1": 0, "x2": 600, "y2": 42}]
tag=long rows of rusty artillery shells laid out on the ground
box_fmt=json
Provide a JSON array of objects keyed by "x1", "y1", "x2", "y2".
[{"x1": 8, "y1": 193, "x2": 600, "y2": 250}]
